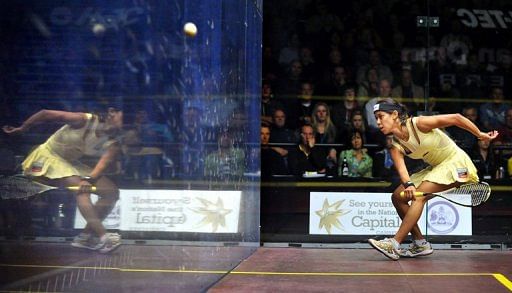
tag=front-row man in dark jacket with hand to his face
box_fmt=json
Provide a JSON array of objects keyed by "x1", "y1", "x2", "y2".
[{"x1": 288, "y1": 125, "x2": 326, "y2": 176}]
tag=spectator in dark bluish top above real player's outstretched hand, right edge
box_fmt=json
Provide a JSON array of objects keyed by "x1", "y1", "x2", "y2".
[{"x1": 479, "y1": 87, "x2": 510, "y2": 130}]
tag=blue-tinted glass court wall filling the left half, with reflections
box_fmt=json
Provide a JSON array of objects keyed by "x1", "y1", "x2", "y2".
[{"x1": 0, "y1": 0, "x2": 262, "y2": 288}]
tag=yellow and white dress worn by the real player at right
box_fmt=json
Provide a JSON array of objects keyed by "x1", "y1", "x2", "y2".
[{"x1": 393, "y1": 117, "x2": 479, "y2": 186}]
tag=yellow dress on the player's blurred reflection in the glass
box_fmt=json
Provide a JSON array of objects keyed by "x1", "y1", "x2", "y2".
[{"x1": 22, "y1": 113, "x2": 115, "y2": 179}]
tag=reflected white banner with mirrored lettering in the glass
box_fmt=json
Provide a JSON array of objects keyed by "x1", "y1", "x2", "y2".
[{"x1": 75, "y1": 190, "x2": 242, "y2": 233}]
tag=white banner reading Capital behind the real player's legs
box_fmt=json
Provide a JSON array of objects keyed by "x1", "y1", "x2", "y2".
[{"x1": 309, "y1": 192, "x2": 472, "y2": 235}]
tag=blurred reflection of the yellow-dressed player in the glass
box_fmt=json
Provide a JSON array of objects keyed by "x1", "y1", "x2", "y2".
[{"x1": 3, "y1": 107, "x2": 123, "y2": 253}]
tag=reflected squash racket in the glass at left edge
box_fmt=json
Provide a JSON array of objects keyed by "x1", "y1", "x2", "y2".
[{"x1": 0, "y1": 176, "x2": 96, "y2": 199}]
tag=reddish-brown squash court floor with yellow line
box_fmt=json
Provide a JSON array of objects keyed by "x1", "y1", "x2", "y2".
[{"x1": 0, "y1": 242, "x2": 512, "y2": 293}]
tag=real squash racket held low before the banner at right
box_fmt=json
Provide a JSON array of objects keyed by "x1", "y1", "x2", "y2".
[{"x1": 400, "y1": 182, "x2": 491, "y2": 207}]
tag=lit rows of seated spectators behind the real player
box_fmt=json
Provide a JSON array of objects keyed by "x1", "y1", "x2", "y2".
[{"x1": 261, "y1": 80, "x2": 512, "y2": 180}]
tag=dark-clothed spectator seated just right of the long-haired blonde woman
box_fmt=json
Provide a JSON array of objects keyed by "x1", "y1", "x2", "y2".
[{"x1": 331, "y1": 85, "x2": 361, "y2": 134}]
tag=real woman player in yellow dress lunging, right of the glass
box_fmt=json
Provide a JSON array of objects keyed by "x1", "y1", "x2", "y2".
[{"x1": 369, "y1": 99, "x2": 498, "y2": 260}]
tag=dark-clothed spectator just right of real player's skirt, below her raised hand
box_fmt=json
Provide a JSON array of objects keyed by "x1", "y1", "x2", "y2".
[{"x1": 469, "y1": 138, "x2": 501, "y2": 180}]
